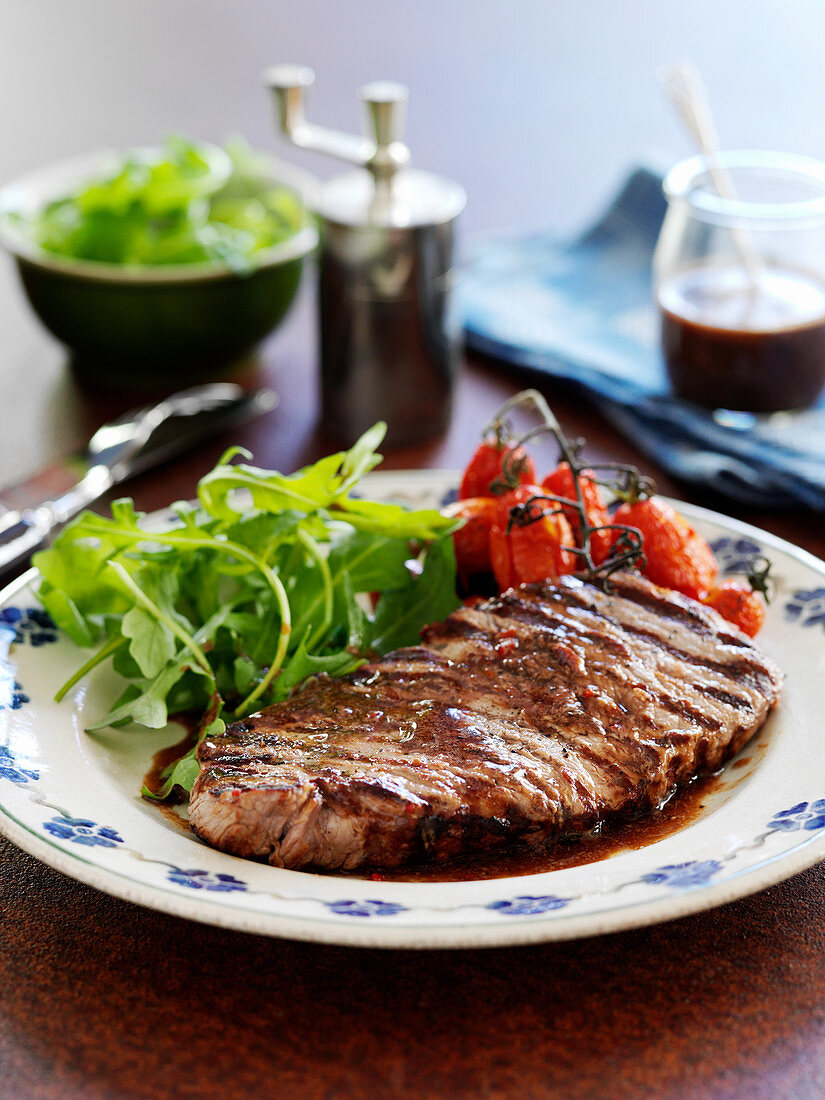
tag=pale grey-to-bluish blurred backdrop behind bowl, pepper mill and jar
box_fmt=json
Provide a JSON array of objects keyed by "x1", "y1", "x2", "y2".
[{"x1": 0, "y1": 0, "x2": 825, "y2": 482}]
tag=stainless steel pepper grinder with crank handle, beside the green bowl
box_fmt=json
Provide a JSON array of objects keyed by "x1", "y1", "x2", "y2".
[{"x1": 263, "y1": 65, "x2": 466, "y2": 446}]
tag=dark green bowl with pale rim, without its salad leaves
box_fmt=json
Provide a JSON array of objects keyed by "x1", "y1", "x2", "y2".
[{"x1": 0, "y1": 144, "x2": 318, "y2": 389}]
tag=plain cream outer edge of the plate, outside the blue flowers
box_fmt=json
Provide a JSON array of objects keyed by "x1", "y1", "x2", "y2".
[{"x1": 0, "y1": 477, "x2": 825, "y2": 950}]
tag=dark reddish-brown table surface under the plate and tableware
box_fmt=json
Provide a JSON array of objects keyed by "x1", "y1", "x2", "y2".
[{"x1": 0, "y1": 287, "x2": 825, "y2": 1100}]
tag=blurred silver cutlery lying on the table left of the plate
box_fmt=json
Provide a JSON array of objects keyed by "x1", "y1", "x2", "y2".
[{"x1": 0, "y1": 382, "x2": 277, "y2": 574}]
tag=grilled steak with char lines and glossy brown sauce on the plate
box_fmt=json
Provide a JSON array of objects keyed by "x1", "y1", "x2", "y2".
[{"x1": 189, "y1": 573, "x2": 781, "y2": 869}]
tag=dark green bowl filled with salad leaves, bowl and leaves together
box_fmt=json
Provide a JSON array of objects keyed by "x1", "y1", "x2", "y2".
[{"x1": 0, "y1": 138, "x2": 318, "y2": 389}]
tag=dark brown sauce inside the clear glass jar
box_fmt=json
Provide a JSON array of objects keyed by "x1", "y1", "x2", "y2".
[{"x1": 658, "y1": 264, "x2": 825, "y2": 413}]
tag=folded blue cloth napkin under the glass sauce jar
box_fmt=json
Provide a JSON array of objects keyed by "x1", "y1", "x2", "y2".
[{"x1": 458, "y1": 168, "x2": 825, "y2": 512}]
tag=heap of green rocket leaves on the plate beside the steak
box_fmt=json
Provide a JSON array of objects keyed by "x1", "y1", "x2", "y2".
[{"x1": 34, "y1": 424, "x2": 460, "y2": 798}]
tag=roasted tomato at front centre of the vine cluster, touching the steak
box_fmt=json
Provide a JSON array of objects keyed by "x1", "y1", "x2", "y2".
[{"x1": 490, "y1": 485, "x2": 576, "y2": 591}]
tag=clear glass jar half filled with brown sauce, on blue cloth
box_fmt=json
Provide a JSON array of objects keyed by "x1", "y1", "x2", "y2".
[{"x1": 653, "y1": 152, "x2": 825, "y2": 413}]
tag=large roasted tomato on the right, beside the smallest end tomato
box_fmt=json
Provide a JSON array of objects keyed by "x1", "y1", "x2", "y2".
[{"x1": 613, "y1": 496, "x2": 719, "y2": 600}]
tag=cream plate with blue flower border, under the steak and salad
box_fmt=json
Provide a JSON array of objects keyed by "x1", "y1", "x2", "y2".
[{"x1": 0, "y1": 471, "x2": 825, "y2": 947}]
